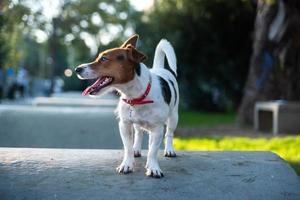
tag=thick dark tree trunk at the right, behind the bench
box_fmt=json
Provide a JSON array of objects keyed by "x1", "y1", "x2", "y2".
[{"x1": 238, "y1": 0, "x2": 300, "y2": 125}]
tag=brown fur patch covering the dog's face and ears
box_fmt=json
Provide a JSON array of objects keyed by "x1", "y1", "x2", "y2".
[{"x1": 90, "y1": 35, "x2": 147, "y2": 84}]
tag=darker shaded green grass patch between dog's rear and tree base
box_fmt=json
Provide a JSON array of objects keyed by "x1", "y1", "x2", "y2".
[{"x1": 178, "y1": 110, "x2": 236, "y2": 128}]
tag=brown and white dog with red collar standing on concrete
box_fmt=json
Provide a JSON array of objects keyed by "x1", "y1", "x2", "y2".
[{"x1": 75, "y1": 35, "x2": 179, "y2": 178}]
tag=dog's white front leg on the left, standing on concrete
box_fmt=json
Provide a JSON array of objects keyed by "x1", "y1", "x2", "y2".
[{"x1": 117, "y1": 121, "x2": 134, "y2": 174}]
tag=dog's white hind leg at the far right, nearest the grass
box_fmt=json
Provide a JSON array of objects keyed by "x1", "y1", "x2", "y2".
[{"x1": 165, "y1": 111, "x2": 178, "y2": 157}]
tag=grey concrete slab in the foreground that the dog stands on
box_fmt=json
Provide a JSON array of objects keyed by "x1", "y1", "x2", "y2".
[{"x1": 0, "y1": 148, "x2": 300, "y2": 200}]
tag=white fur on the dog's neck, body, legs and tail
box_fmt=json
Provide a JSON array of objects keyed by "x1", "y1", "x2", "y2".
[{"x1": 76, "y1": 40, "x2": 179, "y2": 177}]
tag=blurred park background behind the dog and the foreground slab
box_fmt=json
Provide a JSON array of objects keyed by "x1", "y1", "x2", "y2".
[{"x1": 0, "y1": 0, "x2": 300, "y2": 171}]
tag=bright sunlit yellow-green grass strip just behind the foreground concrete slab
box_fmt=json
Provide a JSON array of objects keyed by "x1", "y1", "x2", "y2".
[{"x1": 174, "y1": 136, "x2": 300, "y2": 176}]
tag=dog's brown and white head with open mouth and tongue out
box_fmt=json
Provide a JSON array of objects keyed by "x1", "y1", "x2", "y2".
[{"x1": 75, "y1": 35, "x2": 147, "y2": 95}]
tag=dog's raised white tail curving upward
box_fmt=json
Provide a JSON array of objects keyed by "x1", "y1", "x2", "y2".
[{"x1": 153, "y1": 39, "x2": 177, "y2": 76}]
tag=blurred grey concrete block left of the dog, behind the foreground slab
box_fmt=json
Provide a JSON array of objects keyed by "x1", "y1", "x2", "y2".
[{"x1": 0, "y1": 105, "x2": 122, "y2": 149}]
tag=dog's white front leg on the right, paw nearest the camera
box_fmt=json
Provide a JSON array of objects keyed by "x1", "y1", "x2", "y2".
[{"x1": 146, "y1": 126, "x2": 164, "y2": 178}]
